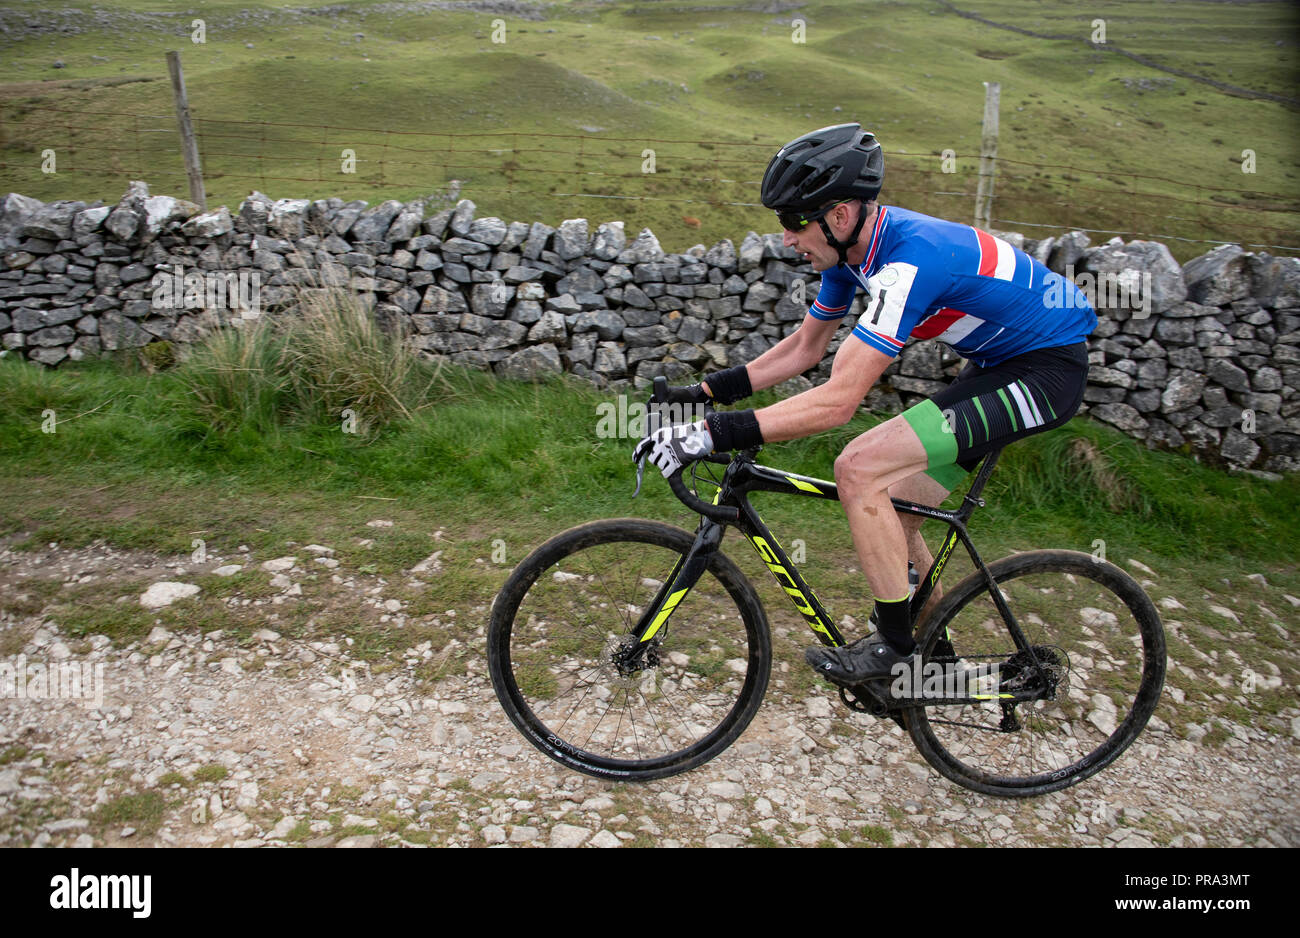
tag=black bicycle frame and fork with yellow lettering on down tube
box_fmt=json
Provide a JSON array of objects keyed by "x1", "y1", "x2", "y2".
[{"x1": 633, "y1": 450, "x2": 1032, "y2": 656}]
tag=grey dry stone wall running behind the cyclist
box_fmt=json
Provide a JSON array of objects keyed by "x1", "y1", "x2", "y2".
[{"x1": 0, "y1": 182, "x2": 1300, "y2": 473}]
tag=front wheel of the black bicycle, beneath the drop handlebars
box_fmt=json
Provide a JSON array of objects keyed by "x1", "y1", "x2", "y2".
[{"x1": 488, "y1": 518, "x2": 772, "y2": 780}]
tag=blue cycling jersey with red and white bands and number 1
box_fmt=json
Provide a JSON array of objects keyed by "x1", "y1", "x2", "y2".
[{"x1": 809, "y1": 205, "x2": 1097, "y2": 368}]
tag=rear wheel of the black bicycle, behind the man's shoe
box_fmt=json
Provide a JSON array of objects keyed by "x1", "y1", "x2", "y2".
[{"x1": 904, "y1": 551, "x2": 1166, "y2": 798}]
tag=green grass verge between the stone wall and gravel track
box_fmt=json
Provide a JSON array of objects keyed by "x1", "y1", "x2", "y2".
[{"x1": 0, "y1": 345, "x2": 1300, "y2": 576}]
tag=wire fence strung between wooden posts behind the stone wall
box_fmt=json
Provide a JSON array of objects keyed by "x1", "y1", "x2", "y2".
[{"x1": 0, "y1": 103, "x2": 1300, "y2": 259}]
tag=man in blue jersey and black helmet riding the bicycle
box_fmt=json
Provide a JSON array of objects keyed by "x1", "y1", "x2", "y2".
[{"x1": 634, "y1": 123, "x2": 1097, "y2": 686}]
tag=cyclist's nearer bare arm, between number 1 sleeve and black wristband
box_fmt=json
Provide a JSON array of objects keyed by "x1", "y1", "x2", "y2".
[{"x1": 754, "y1": 339, "x2": 893, "y2": 443}]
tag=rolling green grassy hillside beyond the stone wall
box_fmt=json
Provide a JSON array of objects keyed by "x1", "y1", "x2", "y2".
[{"x1": 0, "y1": 0, "x2": 1300, "y2": 259}]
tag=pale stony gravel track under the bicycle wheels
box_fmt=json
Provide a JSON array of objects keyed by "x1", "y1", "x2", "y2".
[{"x1": 0, "y1": 532, "x2": 1300, "y2": 847}]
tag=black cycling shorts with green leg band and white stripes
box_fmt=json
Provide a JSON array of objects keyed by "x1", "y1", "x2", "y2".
[{"x1": 902, "y1": 342, "x2": 1088, "y2": 491}]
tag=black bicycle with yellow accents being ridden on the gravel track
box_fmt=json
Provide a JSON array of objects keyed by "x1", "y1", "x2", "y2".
[{"x1": 488, "y1": 378, "x2": 1166, "y2": 796}]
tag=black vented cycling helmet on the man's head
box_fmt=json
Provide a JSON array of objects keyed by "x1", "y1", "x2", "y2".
[{"x1": 762, "y1": 123, "x2": 885, "y2": 266}]
